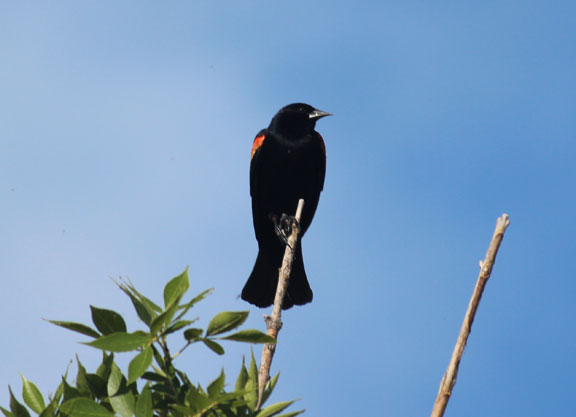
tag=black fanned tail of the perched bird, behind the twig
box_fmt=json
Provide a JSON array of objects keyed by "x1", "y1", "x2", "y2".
[{"x1": 242, "y1": 242, "x2": 313, "y2": 310}]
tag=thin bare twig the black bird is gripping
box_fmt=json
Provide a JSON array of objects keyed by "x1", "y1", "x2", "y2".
[{"x1": 257, "y1": 199, "x2": 304, "y2": 408}]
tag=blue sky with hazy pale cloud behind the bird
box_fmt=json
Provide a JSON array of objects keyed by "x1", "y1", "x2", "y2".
[{"x1": 0, "y1": 1, "x2": 576, "y2": 416}]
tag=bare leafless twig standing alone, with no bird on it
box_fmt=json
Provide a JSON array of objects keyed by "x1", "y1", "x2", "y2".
[{"x1": 431, "y1": 214, "x2": 510, "y2": 417}]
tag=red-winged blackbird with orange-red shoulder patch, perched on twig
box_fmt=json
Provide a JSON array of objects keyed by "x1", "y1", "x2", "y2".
[{"x1": 242, "y1": 103, "x2": 330, "y2": 310}]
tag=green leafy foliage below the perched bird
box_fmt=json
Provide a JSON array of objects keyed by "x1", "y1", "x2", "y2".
[{"x1": 0, "y1": 269, "x2": 303, "y2": 417}]
